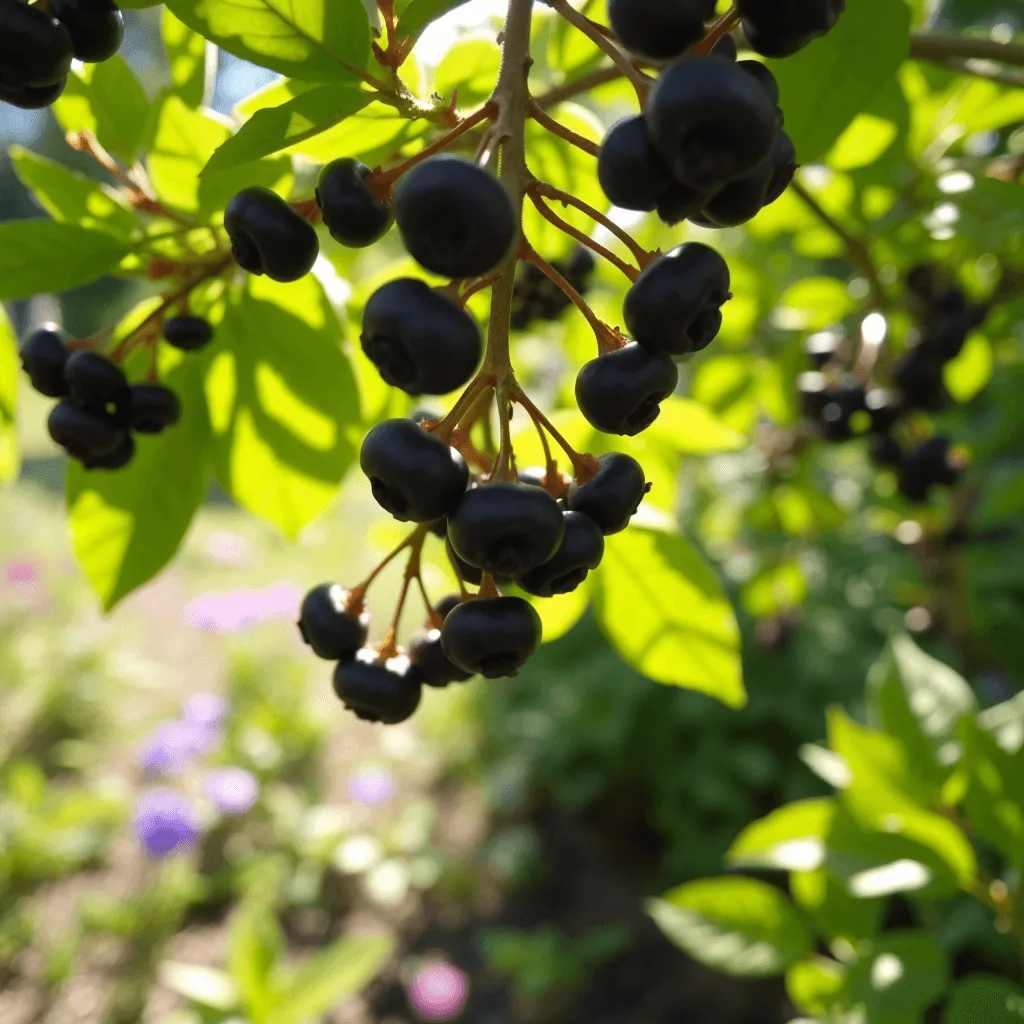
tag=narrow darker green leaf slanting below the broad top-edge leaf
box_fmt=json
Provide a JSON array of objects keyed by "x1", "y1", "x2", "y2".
[{"x1": 201, "y1": 77, "x2": 373, "y2": 177}]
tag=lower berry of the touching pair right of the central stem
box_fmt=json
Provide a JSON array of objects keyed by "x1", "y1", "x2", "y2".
[{"x1": 575, "y1": 343, "x2": 679, "y2": 437}]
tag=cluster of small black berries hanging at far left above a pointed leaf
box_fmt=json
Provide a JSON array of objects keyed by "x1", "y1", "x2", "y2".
[{"x1": 22, "y1": 325, "x2": 181, "y2": 470}]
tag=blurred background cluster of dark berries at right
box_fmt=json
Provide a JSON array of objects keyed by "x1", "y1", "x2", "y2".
[{"x1": 798, "y1": 266, "x2": 987, "y2": 503}]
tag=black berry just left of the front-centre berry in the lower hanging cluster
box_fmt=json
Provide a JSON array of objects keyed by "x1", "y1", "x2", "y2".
[{"x1": 359, "y1": 419, "x2": 469, "y2": 522}]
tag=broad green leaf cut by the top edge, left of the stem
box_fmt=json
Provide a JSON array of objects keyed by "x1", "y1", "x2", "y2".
[{"x1": 167, "y1": 0, "x2": 370, "y2": 82}]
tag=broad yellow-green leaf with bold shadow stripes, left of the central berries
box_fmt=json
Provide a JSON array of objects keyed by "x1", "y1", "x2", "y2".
[{"x1": 207, "y1": 275, "x2": 359, "y2": 537}]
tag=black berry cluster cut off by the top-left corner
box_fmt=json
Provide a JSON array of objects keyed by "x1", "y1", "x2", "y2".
[{"x1": 0, "y1": 0, "x2": 124, "y2": 111}]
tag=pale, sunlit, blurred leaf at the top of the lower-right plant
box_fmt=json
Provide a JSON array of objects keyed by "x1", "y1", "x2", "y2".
[{"x1": 867, "y1": 636, "x2": 975, "y2": 787}]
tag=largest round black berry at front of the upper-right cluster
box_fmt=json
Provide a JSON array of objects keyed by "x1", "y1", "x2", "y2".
[{"x1": 646, "y1": 56, "x2": 779, "y2": 189}]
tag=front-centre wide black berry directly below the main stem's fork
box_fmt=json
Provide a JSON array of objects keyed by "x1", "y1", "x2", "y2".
[{"x1": 449, "y1": 483, "x2": 565, "y2": 577}]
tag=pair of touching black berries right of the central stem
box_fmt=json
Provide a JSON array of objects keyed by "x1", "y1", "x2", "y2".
[{"x1": 575, "y1": 242, "x2": 731, "y2": 436}]
